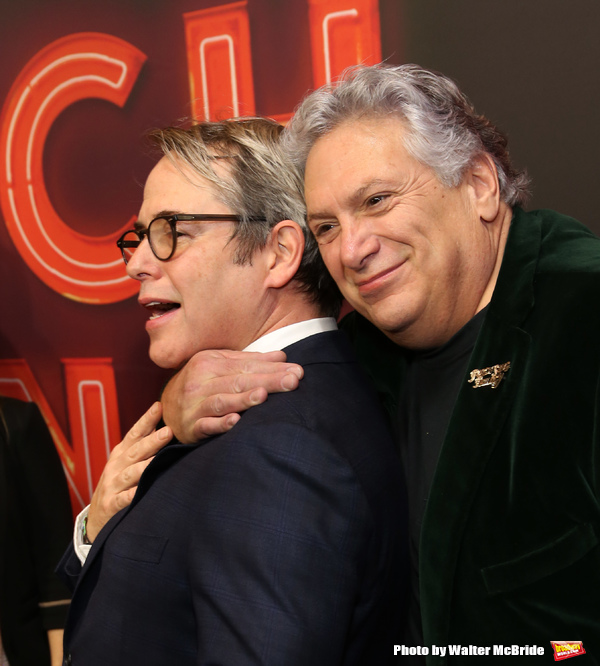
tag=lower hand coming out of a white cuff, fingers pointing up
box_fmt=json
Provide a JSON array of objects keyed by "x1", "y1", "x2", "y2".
[{"x1": 86, "y1": 402, "x2": 173, "y2": 542}]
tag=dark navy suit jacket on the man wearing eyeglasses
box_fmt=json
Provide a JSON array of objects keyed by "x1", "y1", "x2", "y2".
[{"x1": 61, "y1": 331, "x2": 407, "y2": 666}]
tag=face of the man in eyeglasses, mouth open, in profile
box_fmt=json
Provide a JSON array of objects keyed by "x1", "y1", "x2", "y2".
[{"x1": 127, "y1": 157, "x2": 263, "y2": 368}]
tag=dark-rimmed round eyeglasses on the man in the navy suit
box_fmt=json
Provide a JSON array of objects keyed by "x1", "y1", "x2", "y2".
[{"x1": 117, "y1": 214, "x2": 266, "y2": 263}]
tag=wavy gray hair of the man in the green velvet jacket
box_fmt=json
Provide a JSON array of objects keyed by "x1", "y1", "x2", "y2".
[{"x1": 283, "y1": 65, "x2": 529, "y2": 205}]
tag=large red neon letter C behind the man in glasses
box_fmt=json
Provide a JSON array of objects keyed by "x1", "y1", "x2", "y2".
[{"x1": 0, "y1": 33, "x2": 146, "y2": 303}]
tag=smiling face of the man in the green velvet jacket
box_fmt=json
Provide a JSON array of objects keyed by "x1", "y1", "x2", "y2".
[{"x1": 305, "y1": 118, "x2": 501, "y2": 348}]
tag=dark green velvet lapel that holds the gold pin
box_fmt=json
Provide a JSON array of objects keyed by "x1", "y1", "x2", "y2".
[{"x1": 419, "y1": 209, "x2": 541, "y2": 652}]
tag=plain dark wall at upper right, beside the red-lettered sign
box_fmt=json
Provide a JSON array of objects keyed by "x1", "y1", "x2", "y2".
[{"x1": 381, "y1": 0, "x2": 600, "y2": 233}]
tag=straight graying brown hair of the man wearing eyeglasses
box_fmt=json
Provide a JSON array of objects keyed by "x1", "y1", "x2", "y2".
[{"x1": 148, "y1": 118, "x2": 342, "y2": 316}]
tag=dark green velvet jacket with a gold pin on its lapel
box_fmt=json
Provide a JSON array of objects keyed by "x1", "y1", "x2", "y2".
[{"x1": 344, "y1": 208, "x2": 600, "y2": 666}]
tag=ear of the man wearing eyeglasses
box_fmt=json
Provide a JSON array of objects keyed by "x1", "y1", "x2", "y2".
[{"x1": 264, "y1": 220, "x2": 304, "y2": 289}]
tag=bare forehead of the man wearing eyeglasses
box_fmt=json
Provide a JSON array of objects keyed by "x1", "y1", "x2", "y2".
[{"x1": 139, "y1": 157, "x2": 232, "y2": 222}]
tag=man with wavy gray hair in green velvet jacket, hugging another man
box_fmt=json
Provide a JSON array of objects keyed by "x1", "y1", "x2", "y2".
[{"x1": 156, "y1": 65, "x2": 600, "y2": 665}]
